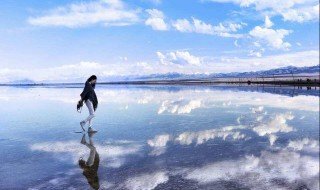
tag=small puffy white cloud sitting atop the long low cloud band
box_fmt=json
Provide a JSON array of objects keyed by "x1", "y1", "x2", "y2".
[{"x1": 157, "y1": 51, "x2": 201, "y2": 65}]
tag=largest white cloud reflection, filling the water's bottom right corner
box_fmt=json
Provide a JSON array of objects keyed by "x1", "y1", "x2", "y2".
[{"x1": 185, "y1": 145, "x2": 319, "y2": 189}]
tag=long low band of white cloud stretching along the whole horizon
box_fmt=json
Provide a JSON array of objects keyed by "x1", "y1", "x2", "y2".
[{"x1": 0, "y1": 50, "x2": 319, "y2": 82}]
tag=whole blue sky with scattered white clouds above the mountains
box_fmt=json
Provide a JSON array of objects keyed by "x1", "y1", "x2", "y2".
[{"x1": 0, "y1": 0, "x2": 319, "y2": 82}]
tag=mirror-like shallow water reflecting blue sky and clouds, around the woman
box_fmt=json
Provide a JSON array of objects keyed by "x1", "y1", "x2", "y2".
[{"x1": 0, "y1": 86, "x2": 319, "y2": 190}]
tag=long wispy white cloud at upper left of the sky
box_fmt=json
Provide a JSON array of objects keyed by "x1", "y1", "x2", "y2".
[{"x1": 28, "y1": 0, "x2": 140, "y2": 28}]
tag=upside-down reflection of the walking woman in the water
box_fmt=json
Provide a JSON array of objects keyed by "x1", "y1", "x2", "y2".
[{"x1": 79, "y1": 133, "x2": 100, "y2": 189}]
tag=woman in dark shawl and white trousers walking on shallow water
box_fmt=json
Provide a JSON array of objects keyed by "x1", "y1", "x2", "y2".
[{"x1": 79, "y1": 75, "x2": 98, "y2": 132}]
